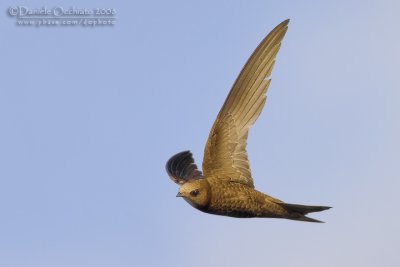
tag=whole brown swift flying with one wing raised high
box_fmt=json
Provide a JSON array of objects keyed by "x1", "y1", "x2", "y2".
[{"x1": 166, "y1": 20, "x2": 330, "y2": 222}]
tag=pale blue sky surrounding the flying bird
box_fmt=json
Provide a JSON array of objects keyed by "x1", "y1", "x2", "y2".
[{"x1": 0, "y1": 0, "x2": 400, "y2": 267}]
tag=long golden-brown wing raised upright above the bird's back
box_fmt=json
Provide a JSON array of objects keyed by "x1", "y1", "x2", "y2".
[{"x1": 203, "y1": 20, "x2": 289, "y2": 187}]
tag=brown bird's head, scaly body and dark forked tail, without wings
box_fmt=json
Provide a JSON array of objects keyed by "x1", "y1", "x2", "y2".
[{"x1": 177, "y1": 175, "x2": 329, "y2": 222}]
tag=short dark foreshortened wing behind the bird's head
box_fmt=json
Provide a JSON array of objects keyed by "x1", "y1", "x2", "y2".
[{"x1": 165, "y1": 151, "x2": 203, "y2": 184}]
